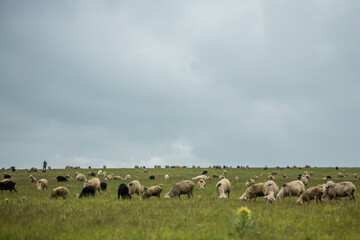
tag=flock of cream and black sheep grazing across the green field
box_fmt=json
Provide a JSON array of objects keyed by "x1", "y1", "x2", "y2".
[{"x1": 0, "y1": 167, "x2": 356, "y2": 204}]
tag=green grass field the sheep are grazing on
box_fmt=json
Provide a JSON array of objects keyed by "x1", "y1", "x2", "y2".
[{"x1": 0, "y1": 168, "x2": 360, "y2": 240}]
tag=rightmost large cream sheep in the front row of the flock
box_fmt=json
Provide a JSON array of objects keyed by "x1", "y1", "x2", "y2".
[{"x1": 323, "y1": 181, "x2": 356, "y2": 200}]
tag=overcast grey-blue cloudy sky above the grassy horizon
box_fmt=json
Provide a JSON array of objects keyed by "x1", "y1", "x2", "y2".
[{"x1": 0, "y1": 0, "x2": 360, "y2": 168}]
